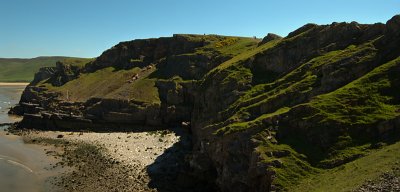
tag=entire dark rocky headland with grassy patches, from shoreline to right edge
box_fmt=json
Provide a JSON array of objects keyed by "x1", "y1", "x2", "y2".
[{"x1": 14, "y1": 16, "x2": 400, "y2": 191}]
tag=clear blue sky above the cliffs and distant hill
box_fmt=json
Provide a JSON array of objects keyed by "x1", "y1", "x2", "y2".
[{"x1": 0, "y1": 0, "x2": 400, "y2": 58}]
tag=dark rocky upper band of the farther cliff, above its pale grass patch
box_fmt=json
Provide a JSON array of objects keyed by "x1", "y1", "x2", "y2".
[{"x1": 84, "y1": 35, "x2": 232, "y2": 79}]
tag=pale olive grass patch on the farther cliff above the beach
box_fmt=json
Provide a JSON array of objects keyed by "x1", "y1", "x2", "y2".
[{"x1": 45, "y1": 67, "x2": 160, "y2": 103}]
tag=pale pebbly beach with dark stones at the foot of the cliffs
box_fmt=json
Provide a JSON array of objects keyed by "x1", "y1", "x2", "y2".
[{"x1": 10, "y1": 127, "x2": 190, "y2": 191}]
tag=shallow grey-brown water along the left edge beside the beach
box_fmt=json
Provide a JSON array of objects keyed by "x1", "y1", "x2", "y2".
[{"x1": 0, "y1": 86, "x2": 58, "y2": 192}]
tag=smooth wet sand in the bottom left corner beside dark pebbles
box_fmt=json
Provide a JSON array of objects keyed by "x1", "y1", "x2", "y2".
[{"x1": 0, "y1": 128, "x2": 63, "y2": 192}]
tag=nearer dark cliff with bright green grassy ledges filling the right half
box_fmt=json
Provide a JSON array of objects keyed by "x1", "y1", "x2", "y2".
[{"x1": 192, "y1": 16, "x2": 400, "y2": 191}]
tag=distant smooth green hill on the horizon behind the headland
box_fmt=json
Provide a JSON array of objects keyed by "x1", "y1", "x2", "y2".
[{"x1": 0, "y1": 57, "x2": 91, "y2": 82}]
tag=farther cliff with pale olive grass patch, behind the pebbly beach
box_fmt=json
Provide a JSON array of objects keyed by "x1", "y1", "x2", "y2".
[{"x1": 12, "y1": 35, "x2": 258, "y2": 129}]
